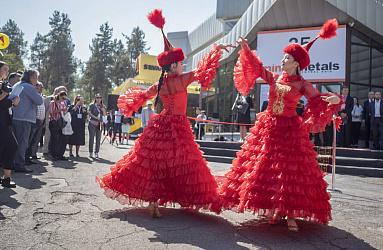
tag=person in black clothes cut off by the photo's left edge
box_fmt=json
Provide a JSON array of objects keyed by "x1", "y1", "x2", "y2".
[{"x1": 0, "y1": 61, "x2": 20, "y2": 188}]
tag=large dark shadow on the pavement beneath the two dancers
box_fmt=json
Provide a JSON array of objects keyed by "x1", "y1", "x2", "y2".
[{"x1": 101, "y1": 208, "x2": 374, "y2": 249}]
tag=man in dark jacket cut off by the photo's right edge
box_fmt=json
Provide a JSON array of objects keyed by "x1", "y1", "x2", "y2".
[{"x1": 370, "y1": 92, "x2": 383, "y2": 150}]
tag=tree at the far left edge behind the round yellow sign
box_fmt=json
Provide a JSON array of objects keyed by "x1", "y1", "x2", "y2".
[{"x1": 1, "y1": 19, "x2": 27, "y2": 72}]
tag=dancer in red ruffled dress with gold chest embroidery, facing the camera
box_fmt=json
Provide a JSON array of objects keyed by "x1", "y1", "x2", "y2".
[{"x1": 220, "y1": 19, "x2": 340, "y2": 231}]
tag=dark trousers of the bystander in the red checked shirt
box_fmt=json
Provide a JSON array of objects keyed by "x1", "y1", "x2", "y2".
[{"x1": 49, "y1": 121, "x2": 67, "y2": 159}]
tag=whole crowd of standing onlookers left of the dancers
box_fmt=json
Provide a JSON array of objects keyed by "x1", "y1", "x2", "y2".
[{"x1": 0, "y1": 61, "x2": 142, "y2": 188}]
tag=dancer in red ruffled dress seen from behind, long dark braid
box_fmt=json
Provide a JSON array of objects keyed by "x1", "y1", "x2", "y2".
[{"x1": 97, "y1": 10, "x2": 234, "y2": 217}]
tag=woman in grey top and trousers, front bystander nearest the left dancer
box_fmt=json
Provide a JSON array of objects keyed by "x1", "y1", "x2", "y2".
[{"x1": 88, "y1": 94, "x2": 106, "y2": 158}]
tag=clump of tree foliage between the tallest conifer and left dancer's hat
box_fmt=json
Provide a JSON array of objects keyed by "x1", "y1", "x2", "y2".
[{"x1": 78, "y1": 23, "x2": 148, "y2": 99}]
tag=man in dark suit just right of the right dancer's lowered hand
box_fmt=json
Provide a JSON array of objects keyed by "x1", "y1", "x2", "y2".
[{"x1": 339, "y1": 86, "x2": 354, "y2": 147}]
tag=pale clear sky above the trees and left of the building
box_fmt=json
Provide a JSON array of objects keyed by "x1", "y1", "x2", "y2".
[{"x1": 0, "y1": 0, "x2": 216, "y2": 61}]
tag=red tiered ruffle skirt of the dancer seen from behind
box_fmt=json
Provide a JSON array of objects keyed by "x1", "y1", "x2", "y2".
[{"x1": 97, "y1": 115, "x2": 221, "y2": 213}]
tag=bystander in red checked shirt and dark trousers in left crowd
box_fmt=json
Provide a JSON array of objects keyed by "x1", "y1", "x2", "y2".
[{"x1": 49, "y1": 91, "x2": 68, "y2": 161}]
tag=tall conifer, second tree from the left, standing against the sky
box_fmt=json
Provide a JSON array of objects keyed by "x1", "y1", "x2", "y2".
[{"x1": 43, "y1": 11, "x2": 77, "y2": 90}]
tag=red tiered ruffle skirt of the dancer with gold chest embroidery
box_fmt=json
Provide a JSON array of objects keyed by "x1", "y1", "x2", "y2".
[{"x1": 220, "y1": 112, "x2": 331, "y2": 224}]
